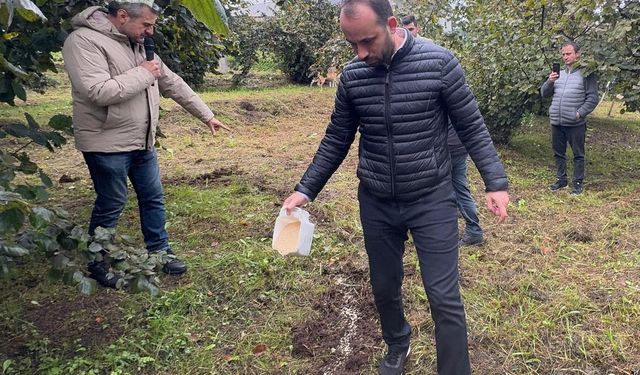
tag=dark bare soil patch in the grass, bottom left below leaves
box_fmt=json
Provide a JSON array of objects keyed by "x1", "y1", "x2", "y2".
[{"x1": 0, "y1": 292, "x2": 126, "y2": 360}]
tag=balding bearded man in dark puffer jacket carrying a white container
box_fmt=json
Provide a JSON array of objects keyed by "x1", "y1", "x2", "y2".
[{"x1": 283, "y1": 0, "x2": 509, "y2": 374}]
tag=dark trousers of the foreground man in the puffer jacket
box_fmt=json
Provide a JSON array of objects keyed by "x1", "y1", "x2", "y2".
[{"x1": 358, "y1": 180, "x2": 471, "y2": 375}]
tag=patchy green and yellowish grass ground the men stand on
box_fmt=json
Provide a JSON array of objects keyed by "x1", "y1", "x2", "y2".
[{"x1": 0, "y1": 71, "x2": 640, "y2": 375}]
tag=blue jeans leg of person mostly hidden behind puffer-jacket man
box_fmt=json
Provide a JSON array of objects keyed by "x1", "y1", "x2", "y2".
[{"x1": 451, "y1": 154, "x2": 482, "y2": 237}]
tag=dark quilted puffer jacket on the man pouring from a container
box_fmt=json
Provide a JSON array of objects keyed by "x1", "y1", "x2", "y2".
[{"x1": 295, "y1": 33, "x2": 507, "y2": 201}]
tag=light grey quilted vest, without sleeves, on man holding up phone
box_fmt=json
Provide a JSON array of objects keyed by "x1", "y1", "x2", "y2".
[{"x1": 549, "y1": 69, "x2": 586, "y2": 126}]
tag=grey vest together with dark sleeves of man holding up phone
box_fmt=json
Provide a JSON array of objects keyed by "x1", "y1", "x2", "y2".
[{"x1": 540, "y1": 69, "x2": 598, "y2": 126}]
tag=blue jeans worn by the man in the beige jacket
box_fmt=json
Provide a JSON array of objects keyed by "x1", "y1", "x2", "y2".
[{"x1": 83, "y1": 149, "x2": 169, "y2": 251}]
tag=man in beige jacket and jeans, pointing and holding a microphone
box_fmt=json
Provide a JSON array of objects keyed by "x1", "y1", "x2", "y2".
[{"x1": 62, "y1": 0, "x2": 229, "y2": 288}]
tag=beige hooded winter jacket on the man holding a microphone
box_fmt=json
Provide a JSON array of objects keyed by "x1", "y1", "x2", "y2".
[{"x1": 62, "y1": 6, "x2": 213, "y2": 152}]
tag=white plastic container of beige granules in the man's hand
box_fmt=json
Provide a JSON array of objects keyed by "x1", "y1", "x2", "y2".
[{"x1": 271, "y1": 208, "x2": 315, "y2": 256}]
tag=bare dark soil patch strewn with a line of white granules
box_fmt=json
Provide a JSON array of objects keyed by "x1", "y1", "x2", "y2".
[{"x1": 291, "y1": 263, "x2": 382, "y2": 375}]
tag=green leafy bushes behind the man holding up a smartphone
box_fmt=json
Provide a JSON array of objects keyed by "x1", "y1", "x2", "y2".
[{"x1": 441, "y1": 0, "x2": 640, "y2": 143}]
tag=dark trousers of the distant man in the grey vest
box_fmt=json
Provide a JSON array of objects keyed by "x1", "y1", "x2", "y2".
[{"x1": 551, "y1": 124, "x2": 587, "y2": 183}]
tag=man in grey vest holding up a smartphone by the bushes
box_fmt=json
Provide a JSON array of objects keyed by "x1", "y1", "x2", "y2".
[{"x1": 540, "y1": 42, "x2": 598, "y2": 195}]
